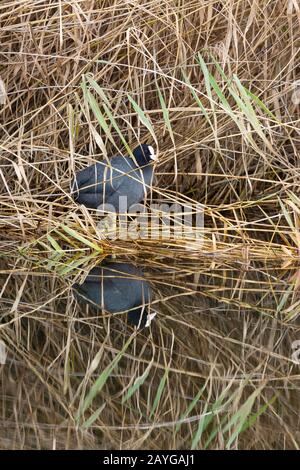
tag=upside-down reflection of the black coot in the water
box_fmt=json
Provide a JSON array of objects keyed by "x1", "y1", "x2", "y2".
[{"x1": 73, "y1": 262, "x2": 156, "y2": 328}]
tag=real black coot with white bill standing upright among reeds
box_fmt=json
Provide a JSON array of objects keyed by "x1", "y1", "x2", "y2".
[{"x1": 72, "y1": 144, "x2": 157, "y2": 209}]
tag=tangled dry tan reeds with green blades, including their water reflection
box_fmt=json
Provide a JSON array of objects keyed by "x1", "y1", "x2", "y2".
[{"x1": 0, "y1": 0, "x2": 300, "y2": 449}]
